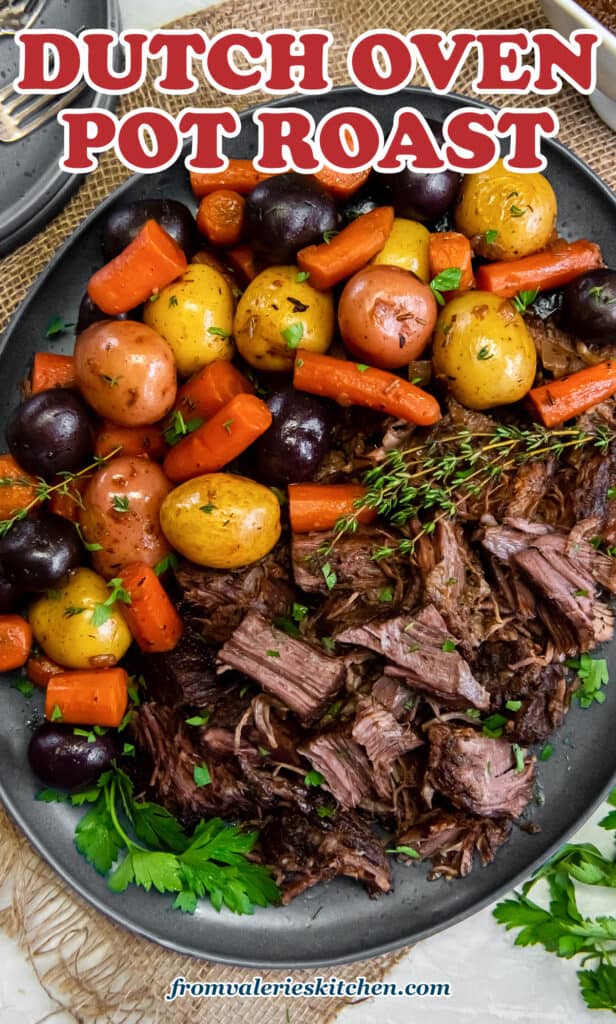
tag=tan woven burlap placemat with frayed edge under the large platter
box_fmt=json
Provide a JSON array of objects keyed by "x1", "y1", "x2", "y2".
[{"x1": 0, "y1": 0, "x2": 616, "y2": 1024}]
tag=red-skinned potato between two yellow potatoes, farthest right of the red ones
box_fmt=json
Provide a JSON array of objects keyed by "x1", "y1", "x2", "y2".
[{"x1": 338, "y1": 264, "x2": 438, "y2": 370}]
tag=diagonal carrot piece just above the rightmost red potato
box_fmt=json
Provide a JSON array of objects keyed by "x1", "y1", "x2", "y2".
[{"x1": 297, "y1": 206, "x2": 394, "y2": 291}]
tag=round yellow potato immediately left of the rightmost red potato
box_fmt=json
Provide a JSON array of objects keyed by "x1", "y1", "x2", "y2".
[{"x1": 233, "y1": 266, "x2": 334, "y2": 373}]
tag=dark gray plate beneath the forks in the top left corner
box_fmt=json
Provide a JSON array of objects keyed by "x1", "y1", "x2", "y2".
[{"x1": 0, "y1": 0, "x2": 120, "y2": 256}]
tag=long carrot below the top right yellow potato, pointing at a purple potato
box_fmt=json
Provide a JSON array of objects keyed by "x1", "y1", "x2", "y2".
[{"x1": 477, "y1": 239, "x2": 604, "y2": 299}]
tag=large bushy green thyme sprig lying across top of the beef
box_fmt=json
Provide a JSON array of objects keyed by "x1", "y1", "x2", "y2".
[{"x1": 321, "y1": 424, "x2": 614, "y2": 559}]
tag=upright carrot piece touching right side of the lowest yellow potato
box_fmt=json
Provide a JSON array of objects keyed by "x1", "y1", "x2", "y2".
[{"x1": 115, "y1": 562, "x2": 183, "y2": 651}]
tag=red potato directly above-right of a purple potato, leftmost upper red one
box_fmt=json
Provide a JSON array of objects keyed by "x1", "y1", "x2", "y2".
[{"x1": 74, "y1": 321, "x2": 177, "y2": 427}]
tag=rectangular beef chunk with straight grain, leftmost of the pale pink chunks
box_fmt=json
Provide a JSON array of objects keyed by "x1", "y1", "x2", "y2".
[{"x1": 219, "y1": 611, "x2": 347, "y2": 721}]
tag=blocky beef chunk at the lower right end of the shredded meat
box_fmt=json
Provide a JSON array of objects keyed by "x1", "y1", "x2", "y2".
[{"x1": 426, "y1": 724, "x2": 535, "y2": 818}]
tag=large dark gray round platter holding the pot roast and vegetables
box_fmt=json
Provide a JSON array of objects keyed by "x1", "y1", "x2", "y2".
[{"x1": 0, "y1": 88, "x2": 616, "y2": 968}]
